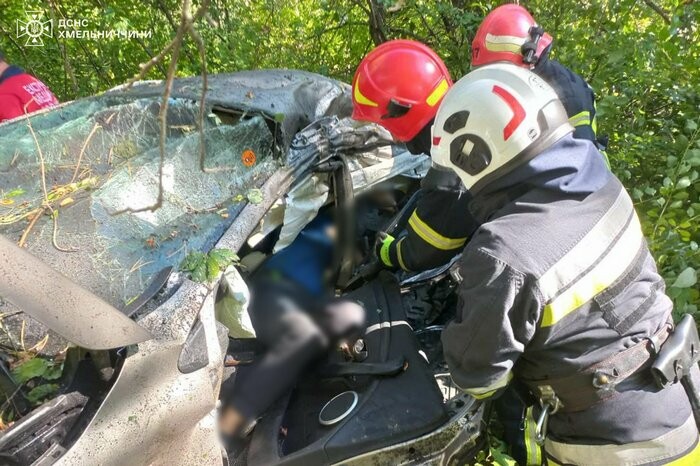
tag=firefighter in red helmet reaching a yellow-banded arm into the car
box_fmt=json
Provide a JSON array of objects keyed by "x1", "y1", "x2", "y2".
[{"x1": 352, "y1": 40, "x2": 477, "y2": 271}]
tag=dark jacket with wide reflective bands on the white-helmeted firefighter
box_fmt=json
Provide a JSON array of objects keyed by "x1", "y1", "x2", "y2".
[{"x1": 442, "y1": 135, "x2": 700, "y2": 465}]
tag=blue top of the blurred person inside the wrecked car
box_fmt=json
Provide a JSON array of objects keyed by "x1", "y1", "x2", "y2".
[{"x1": 262, "y1": 214, "x2": 334, "y2": 296}]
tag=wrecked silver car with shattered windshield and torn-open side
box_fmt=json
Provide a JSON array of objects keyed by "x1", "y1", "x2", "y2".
[{"x1": 0, "y1": 71, "x2": 484, "y2": 465}]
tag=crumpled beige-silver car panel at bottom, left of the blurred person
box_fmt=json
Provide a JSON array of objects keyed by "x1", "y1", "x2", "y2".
[{"x1": 56, "y1": 280, "x2": 225, "y2": 466}]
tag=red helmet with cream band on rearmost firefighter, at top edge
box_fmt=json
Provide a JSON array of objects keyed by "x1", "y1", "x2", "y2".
[{"x1": 472, "y1": 4, "x2": 552, "y2": 68}]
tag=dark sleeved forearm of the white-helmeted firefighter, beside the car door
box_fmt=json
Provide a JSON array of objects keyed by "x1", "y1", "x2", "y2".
[{"x1": 442, "y1": 247, "x2": 540, "y2": 399}]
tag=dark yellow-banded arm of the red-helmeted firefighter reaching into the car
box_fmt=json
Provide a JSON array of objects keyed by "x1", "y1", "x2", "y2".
[{"x1": 379, "y1": 170, "x2": 478, "y2": 271}]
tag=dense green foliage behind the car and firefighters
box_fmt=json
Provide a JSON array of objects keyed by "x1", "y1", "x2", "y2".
[{"x1": 0, "y1": 0, "x2": 700, "y2": 313}]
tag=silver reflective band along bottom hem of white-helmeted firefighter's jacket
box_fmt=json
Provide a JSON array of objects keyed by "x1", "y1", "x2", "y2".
[{"x1": 544, "y1": 416, "x2": 698, "y2": 466}]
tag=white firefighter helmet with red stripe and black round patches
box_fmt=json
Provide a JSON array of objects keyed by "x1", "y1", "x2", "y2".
[{"x1": 431, "y1": 63, "x2": 573, "y2": 192}]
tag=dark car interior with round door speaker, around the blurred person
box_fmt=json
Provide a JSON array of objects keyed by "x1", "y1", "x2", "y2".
[{"x1": 222, "y1": 159, "x2": 470, "y2": 465}]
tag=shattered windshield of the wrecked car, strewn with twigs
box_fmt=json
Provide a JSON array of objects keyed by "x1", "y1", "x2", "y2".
[{"x1": 0, "y1": 94, "x2": 278, "y2": 311}]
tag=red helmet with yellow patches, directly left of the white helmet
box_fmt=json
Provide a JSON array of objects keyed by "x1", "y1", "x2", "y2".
[{"x1": 352, "y1": 40, "x2": 452, "y2": 141}]
